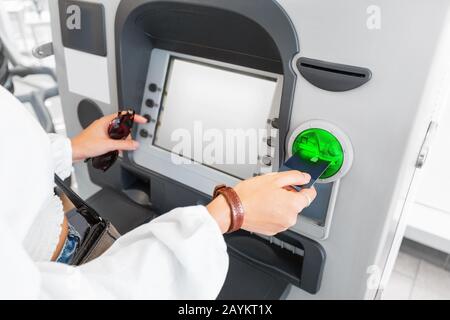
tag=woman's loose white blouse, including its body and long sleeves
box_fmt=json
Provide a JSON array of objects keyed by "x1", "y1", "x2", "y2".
[{"x1": 0, "y1": 87, "x2": 228, "y2": 299}]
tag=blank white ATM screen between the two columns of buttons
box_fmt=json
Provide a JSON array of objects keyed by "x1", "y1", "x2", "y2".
[{"x1": 153, "y1": 57, "x2": 277, "y2": 179}]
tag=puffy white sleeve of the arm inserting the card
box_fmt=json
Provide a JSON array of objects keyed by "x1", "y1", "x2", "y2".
[{"x1": 33, "y1": 206, "x2": 228, "y2": 299}]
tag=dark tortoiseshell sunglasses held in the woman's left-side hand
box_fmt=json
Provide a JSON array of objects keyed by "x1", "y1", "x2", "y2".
[{"x1": 86, "y1": 110, "x2": 136, "y2": 172}]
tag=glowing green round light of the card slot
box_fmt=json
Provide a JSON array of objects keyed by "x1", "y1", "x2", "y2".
[{"x1": 292, "y1": 128, "x2": 344, "y2": 179}]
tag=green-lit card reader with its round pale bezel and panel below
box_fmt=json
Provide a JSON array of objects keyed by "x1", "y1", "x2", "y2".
[{"x1": 281, "y1": 120, "x2": 353, "y2": 240}]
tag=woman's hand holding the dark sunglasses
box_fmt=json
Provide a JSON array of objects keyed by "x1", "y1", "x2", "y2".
[{"x1": 72, "y1": 113, "x2": 147, "y2": 161}]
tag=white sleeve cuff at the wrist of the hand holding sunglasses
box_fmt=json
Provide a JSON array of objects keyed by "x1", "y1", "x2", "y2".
[{"x1": 48, "y1": 133, "x2": 72, "y2": 180}]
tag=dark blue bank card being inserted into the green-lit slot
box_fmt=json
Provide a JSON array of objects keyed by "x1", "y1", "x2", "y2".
[{"x1": 279, "y1": 155, "x2": 330, "y2": 191}]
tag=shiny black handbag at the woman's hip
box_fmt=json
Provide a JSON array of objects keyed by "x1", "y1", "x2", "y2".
[{"x1": 55, "y1": 175, "x2": 120, "y2": 266}]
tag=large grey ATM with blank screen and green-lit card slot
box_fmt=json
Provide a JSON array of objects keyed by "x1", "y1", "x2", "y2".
[{"x1": 45, "y1": 0, "x2": 450, "y2": 299}]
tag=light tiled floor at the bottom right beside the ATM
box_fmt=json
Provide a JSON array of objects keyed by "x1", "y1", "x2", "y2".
[{"x1": 383, "y1": 240, "x2": 450, "y2": 300}]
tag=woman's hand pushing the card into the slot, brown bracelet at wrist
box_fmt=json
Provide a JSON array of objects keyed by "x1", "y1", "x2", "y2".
[{"x1": 207, "y1": 171, "x2": 317, "y2": 236}]
